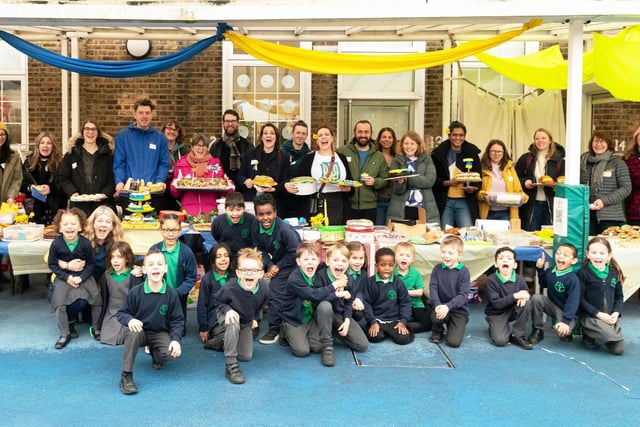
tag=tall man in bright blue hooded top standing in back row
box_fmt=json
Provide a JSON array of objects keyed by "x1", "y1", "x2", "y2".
[{"x1": 113, "y1": 99, "x2": 169, "y2": 211}]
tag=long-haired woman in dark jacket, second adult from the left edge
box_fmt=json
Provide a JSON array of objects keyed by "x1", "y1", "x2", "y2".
[{"x1": 20, "y1": 132, "x2": 66, "y2": 225}]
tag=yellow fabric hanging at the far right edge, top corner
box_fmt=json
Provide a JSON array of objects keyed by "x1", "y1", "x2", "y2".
[{"x1": 593, "y1": 26, "x2": 640, "y2": 102}]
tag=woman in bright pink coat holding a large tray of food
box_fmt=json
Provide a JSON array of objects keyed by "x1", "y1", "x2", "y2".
[{"x1": 169, "y1": 133, "x2": 235, "y2": 216}]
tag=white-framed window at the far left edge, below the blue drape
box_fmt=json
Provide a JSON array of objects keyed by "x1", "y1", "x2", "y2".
[{"x1": 0, "y1": 42, "x2": 29, "y2": 151}]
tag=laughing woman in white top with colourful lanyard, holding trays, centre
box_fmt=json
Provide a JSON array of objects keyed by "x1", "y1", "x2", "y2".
[{"x1": 285, "y1": 125, "x2": 353, "y2": 225}]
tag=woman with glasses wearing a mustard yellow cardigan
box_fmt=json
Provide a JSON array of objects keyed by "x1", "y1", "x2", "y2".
[{"x1": 478, "y1": 139, "x2": 529, "y2": 220}]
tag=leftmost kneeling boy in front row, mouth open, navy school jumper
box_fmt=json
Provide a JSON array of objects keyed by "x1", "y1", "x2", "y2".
[{"x1": 116, "y1": 248, "x2": 184, "y2": 394}]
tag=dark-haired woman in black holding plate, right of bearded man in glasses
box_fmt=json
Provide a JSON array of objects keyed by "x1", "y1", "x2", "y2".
[{"x1": 238, "y1": 123, "x2": 290, "y2": 214}]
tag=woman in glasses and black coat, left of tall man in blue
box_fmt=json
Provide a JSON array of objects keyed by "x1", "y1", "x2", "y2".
[{"x1": 60, "y1": 120, "x2": 116, "y2": 216}]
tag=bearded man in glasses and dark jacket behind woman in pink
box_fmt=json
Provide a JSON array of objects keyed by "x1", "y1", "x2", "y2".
[{"x1": 209, "y1": 110, "x2": 253, "y2": 188}]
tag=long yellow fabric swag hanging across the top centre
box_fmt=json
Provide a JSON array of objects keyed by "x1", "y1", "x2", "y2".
[{"x1": 224, "y1": 19, "x2": 542, "y2": 74}]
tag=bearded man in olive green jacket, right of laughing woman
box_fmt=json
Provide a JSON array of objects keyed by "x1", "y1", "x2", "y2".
[{"x1": 338, "y1": 120, "x2": 389, "y2": 222}]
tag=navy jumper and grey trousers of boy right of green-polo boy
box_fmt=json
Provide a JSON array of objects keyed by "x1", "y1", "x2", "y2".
[{"x1": 429, "y1": 262, "x2": 471, "y2": 347}]
